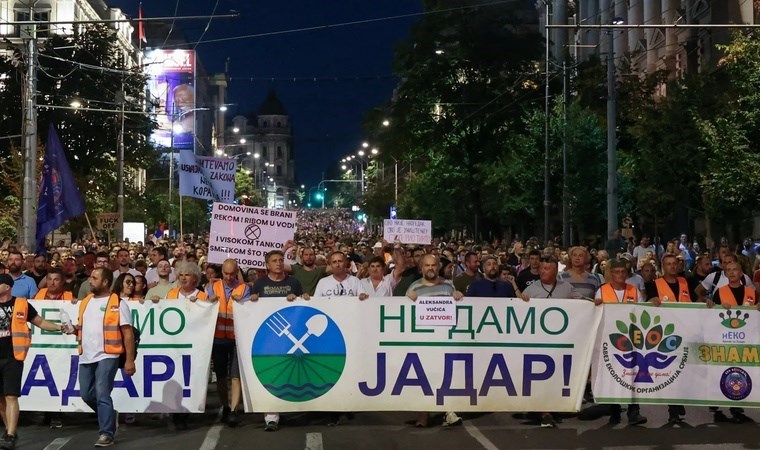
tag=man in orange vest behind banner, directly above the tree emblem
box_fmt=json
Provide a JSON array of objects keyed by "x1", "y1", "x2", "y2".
[{"x1": 594, "y1": 259, "x2": 647, "y2": 425}]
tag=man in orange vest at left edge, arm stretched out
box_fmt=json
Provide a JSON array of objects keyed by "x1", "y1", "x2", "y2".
[{"x1": 0, "y1": 273, "x2": 64, "y2": 450}]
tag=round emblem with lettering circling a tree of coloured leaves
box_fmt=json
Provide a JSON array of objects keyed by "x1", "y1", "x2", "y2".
[{"x1": 602, "y1": 311, "x2": 689, "y2": 386}]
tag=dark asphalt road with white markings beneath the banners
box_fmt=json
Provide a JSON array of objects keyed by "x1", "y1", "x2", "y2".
[{"x1": 17, "y1": 393, "x2": 760, "y2": 450}]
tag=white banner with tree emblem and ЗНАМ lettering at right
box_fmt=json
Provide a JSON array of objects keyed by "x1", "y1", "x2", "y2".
[{"x1": 592, "y1": 303, "x2": 760, "y2": 407}]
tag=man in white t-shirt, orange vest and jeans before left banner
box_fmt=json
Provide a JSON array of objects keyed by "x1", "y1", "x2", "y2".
[{"x1": 76, "y1": 267, "x2": 135, "y2": 447}]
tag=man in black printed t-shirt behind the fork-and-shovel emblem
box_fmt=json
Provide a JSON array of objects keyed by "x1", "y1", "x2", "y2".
[{"x1": 251, "y1": 250, "x2": 309, "y2": 431}]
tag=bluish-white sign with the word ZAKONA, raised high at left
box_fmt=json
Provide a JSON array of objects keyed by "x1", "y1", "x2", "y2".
[{"x1": 179, "y1": 150, "x2": 237, "y2": 203}]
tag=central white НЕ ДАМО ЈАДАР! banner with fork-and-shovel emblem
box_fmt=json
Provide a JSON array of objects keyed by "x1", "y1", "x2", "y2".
[{"x1": 234, "y1": 297, "x2": 602, "y2": 412}]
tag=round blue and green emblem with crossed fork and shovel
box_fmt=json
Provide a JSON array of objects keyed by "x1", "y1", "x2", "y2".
[{"x1": 251, "y1": 306, "x2": 346, "y2": 402}]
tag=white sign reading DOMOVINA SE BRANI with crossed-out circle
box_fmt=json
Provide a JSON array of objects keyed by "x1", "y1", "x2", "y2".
[{"x1": 208, "y1": 203, "x2": 296, "y2": 269}]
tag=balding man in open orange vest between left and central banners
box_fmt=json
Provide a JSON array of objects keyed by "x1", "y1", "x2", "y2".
[{"x1": 207, "y1": 259, "x2": 251, "y2": 427}]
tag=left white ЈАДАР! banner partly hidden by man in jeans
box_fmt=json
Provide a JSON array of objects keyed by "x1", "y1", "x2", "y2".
[{"x1": 19, "y1": 300, "x2": 218, "y2": 413}]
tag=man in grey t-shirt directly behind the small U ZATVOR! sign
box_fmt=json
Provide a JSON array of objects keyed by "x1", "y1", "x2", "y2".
[{"x1": 406, "y1": 254, "x2": 464, "y2": 428}]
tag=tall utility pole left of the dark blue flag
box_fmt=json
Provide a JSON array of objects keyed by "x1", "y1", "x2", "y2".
[{"x1": 21, "y1": 15, "x2": 37, "y2": 251}]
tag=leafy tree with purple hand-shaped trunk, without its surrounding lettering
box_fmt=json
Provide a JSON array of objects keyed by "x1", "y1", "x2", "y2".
[{"x1": 610, "y1": 311, "x2": 682, "y2": 383}]
